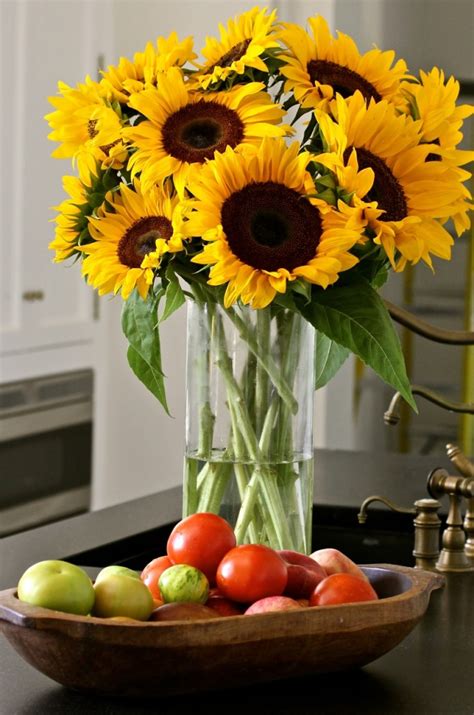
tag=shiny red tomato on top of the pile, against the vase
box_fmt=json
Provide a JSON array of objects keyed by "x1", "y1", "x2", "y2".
[{"x1": 166, "y1": 512, "x2": 236, "y2": 584}]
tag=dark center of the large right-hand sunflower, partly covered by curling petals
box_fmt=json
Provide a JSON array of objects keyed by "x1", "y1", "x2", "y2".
[{"x1": 344, "y1": 147, "x2": 408, "y2": 221}]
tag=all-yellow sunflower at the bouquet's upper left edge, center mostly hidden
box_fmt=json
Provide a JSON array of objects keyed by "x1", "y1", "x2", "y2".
[{"x1": 45, "y1": 77, "x2": 127, "y2": 172}]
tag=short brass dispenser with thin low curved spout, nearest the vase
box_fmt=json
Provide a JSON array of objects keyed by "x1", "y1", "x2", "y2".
[{"x1": 357, "y1": 494, "x2": 441, "y2": 571}]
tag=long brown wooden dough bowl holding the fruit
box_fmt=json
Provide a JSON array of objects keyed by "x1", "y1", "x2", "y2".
[{"x1": 0, "y1": 564, "x2": 443, "y2": 697}]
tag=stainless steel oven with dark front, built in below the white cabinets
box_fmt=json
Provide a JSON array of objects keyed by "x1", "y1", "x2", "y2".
[{"x1": 0, "y1": 370, "x2": 93, "y2": 536}]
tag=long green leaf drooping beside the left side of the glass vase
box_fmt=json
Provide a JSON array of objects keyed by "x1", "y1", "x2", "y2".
[{"x1": 122, "y1": 291, "x2": 170, "y2": 414}]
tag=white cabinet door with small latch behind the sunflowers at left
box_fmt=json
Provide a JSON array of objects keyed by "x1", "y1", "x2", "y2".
[{"x1": 0, "y1": 0, "x2": 112, "y2": 379}]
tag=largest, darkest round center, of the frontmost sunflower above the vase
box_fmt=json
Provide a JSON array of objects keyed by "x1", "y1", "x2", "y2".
[{"x1": 221, "y1": 181, "x2": 322, "y2": 271}]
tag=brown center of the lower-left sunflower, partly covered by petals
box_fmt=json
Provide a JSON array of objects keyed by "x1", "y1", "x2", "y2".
[{"x1": 117, "y1": 216, "x2": 173, "y2": 268}]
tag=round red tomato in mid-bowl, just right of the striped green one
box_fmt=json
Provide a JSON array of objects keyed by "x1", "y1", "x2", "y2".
[{"x1": 216, "y1": 544, "x2": 288, "y2": 603}]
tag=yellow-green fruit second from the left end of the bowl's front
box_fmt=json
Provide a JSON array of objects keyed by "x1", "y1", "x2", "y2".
[{"x1": 93, "y1": 572, "x2": 155, "y2": 621}]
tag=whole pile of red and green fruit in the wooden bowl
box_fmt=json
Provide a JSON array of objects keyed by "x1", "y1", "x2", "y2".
[{"x1": 14, "y1": 513, "x2": 386, "y2": 621}]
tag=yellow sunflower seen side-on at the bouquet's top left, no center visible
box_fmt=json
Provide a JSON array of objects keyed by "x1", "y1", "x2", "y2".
[{"x1": 101, "y1": 32, "x2": 197, "y2": 104}]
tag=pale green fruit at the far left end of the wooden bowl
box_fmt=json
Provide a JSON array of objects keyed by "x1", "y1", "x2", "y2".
[{"x1": 18, "y1": 560, "x2": 94, "y2": 616}]
